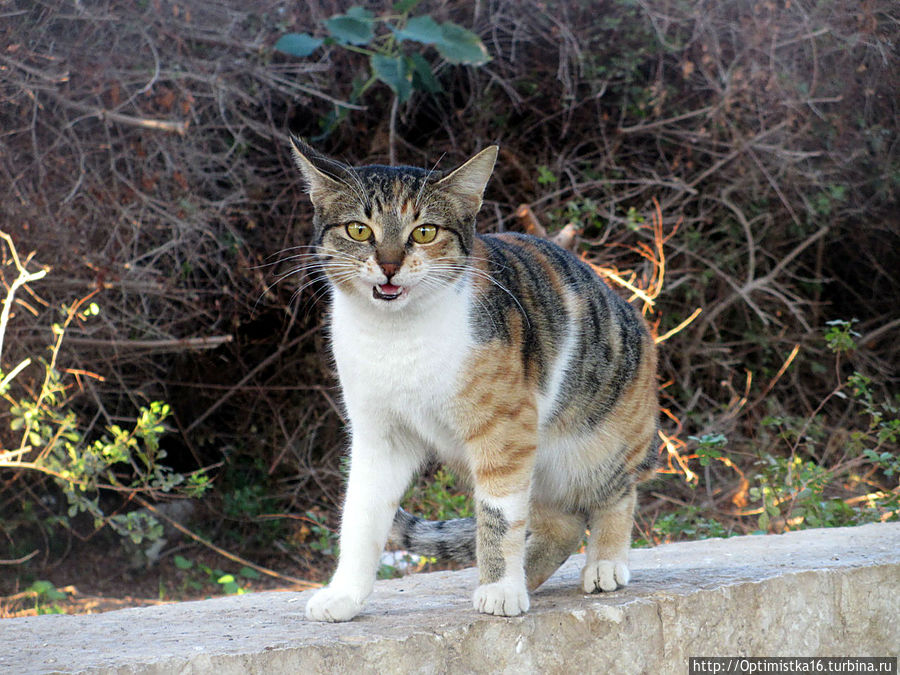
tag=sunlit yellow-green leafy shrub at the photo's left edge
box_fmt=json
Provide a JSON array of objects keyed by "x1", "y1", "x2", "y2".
[{"x1": 0, "y1": 233, "x2": 208, "y2": 544}]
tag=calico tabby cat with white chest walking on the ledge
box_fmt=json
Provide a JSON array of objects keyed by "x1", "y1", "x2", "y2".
[{"x1": 292, "y1": 137, "x2": 658, "y2": 621}]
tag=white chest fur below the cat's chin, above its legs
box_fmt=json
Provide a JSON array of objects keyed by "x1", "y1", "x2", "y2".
[{"x1": 332, "y1": 282, "x2": 472, "y2": 455}]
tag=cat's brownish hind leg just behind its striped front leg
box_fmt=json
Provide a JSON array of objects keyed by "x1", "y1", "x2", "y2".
[{"x1": 525, "y1": 504, "x2": 586, "y2": 591}]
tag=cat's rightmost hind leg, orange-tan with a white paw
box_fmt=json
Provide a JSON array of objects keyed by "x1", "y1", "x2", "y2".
[{"x1": 581, "y1": 485, "x2": 637, "y2": 593}]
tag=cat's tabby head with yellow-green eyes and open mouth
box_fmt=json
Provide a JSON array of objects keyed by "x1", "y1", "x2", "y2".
[{"x1": 291, "y1": 138, "x2": 497, "y2": 311}]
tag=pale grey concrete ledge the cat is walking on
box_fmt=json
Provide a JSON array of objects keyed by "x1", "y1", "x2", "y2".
[{"x1": 8, "y1": 523, "x2": 900, "y2": 675}]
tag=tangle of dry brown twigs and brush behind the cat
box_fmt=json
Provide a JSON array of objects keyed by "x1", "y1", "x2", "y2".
[{"x1": 0, "y1": 0, "x2": 900, "y2": 612}]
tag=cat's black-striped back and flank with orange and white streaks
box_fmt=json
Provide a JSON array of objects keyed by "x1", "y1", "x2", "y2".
[{"x1": 473, "y1": 233, "x2": 656, "y2": 434}]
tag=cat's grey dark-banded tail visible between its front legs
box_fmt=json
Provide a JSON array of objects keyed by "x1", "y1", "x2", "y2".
[{"x1": 390, "y1": 509, "x2": 475, "y2": 563}]
